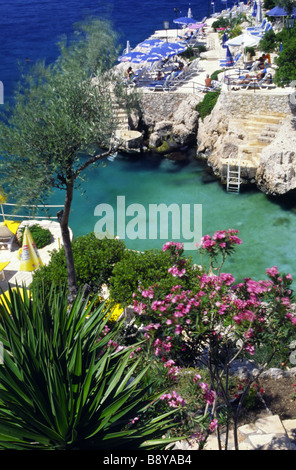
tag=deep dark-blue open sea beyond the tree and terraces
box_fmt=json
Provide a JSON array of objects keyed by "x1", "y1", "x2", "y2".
[{"x1": 0, "y1": 0, "x2": 234, "y2": 99}]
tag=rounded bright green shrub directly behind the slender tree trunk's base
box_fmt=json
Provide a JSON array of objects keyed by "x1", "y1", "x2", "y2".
[{"x1": 33, "y1": 232, "x2": 126, "y2": 292}]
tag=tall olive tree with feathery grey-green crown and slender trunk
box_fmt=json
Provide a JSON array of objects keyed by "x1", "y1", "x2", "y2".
[{"x1": 0, "y1": 18, "x2": 139, "y2": 298}]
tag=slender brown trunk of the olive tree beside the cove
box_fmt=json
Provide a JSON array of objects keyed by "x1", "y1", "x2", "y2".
[{"x1": 57, "y1": 180, "x2": 78, "y2": 304}]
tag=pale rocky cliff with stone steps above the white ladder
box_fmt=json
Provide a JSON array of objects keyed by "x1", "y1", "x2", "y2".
[{"x1": 197, "y1": 90, "x2": 296, "y2": 195}]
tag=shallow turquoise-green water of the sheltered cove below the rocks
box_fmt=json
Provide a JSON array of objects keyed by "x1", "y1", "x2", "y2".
[{"x1": 49, "y1": 151, "x2": 296, "y2": 280}]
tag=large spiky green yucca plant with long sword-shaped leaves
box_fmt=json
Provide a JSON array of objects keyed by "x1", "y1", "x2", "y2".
[{"x1": 0, "y1": 286, "x2": 183, "y2": 450}]
